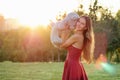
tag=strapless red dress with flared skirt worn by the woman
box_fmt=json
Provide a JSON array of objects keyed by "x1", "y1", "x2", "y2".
[{"x1": 62, "y1": 46, "x2": 88, "y2": 80}]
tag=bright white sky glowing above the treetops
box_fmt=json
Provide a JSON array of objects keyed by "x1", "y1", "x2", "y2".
[{"x1": 0, "y1": 0, "x2": 120, "y2": 26}]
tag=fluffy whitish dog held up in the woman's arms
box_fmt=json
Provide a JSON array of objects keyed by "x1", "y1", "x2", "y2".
[{"x1": 50, "y1": 12, "x2": 80, "y2": 48}]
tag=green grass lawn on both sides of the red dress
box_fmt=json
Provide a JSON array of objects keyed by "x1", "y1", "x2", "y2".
[{"x1": 0, "y1": 61, "x2": 120, "y2": 80}]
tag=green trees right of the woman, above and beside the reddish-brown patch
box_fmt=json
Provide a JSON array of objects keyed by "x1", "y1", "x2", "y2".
[{"x1": 83, "y1": 0, "x2": 120, "y2": 62}]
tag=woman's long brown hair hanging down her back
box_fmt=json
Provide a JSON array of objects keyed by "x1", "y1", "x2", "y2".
[{"x1": 81, "y1": 16, "x2": 94, "y2": 63}]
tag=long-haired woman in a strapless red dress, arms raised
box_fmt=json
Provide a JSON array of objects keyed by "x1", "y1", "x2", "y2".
[{"x1": 60, "y1": 16, "x2": 94, "y2": 80}]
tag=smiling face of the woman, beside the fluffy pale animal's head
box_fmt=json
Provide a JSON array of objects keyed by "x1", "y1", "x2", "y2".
[{"x1": 76, "y1": 17, "x2": 86, "y2": 31}]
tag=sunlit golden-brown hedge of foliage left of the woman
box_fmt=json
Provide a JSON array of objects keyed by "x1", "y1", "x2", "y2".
[{"x1": 0, "y1": 26, "x2": 64, "y2": 62}]
